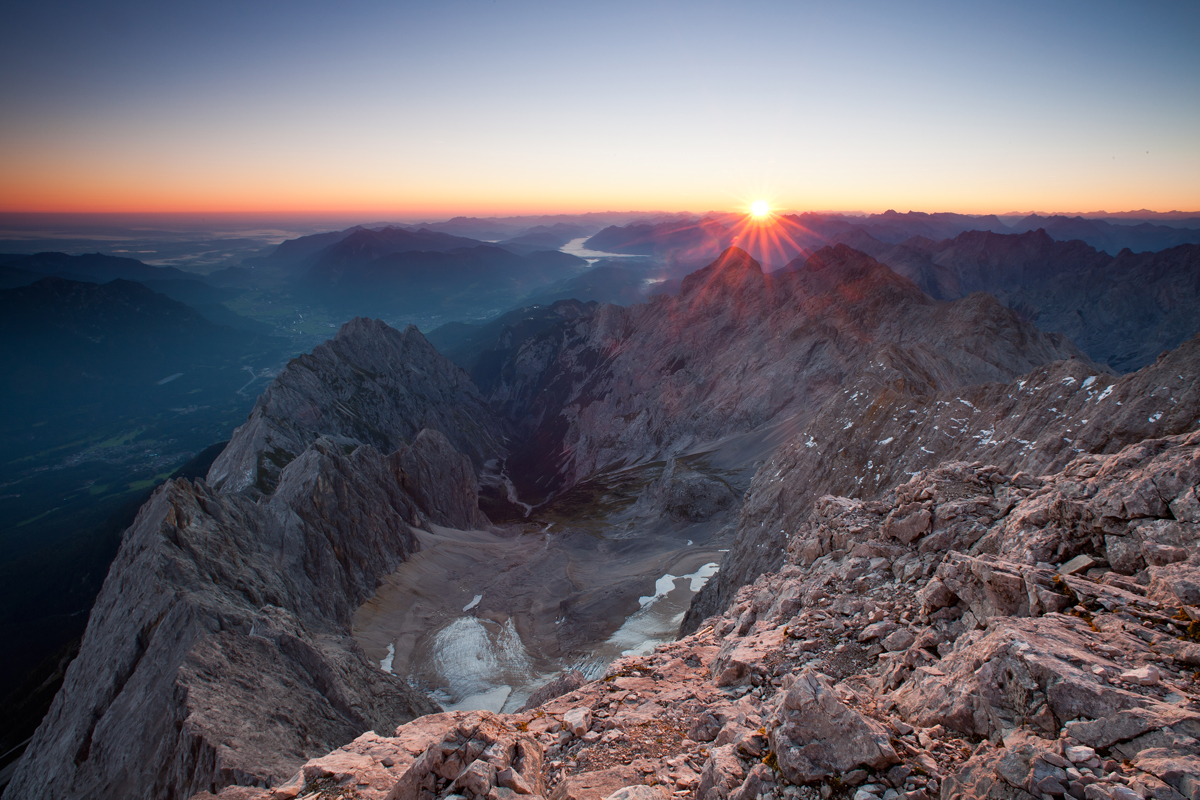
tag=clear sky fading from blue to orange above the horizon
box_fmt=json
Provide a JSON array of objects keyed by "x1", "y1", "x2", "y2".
[{"x1": 0, "y1": 0, "x2": 1200, "y2": 217}]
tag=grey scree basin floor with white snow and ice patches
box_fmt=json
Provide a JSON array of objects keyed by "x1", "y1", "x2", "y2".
[{"x1": 353, "y1": 510, "x2": 732, "y2": 711}]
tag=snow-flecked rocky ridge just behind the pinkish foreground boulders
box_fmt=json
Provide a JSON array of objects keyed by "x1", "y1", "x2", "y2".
[{"x1": 684, "y1": 336, "x2": 1200, "y2": 632}]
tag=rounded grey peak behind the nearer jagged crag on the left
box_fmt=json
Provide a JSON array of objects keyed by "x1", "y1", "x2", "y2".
[{"x1": 208, "y1": 317, "x2": 503, "y2": 493}]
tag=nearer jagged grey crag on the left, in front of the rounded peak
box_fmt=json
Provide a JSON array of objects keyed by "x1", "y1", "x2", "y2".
[{"x1": 6, "y1": 431, "x2": 486, "y2": 800}]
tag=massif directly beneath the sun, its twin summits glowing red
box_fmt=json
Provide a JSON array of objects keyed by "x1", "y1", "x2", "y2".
[{"x1": 488, "y1": 246, "x2": 1084, "y2": 497}]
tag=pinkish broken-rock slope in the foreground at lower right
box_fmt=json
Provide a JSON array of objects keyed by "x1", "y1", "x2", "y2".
[{"x1": 197, "y1": 432, "x2": 1200, "y2": 800}]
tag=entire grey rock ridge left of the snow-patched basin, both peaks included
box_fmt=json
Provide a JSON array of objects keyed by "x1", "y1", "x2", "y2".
[{"x1": 5, "y1": 320, "x2": 494, "y2": 799}]
